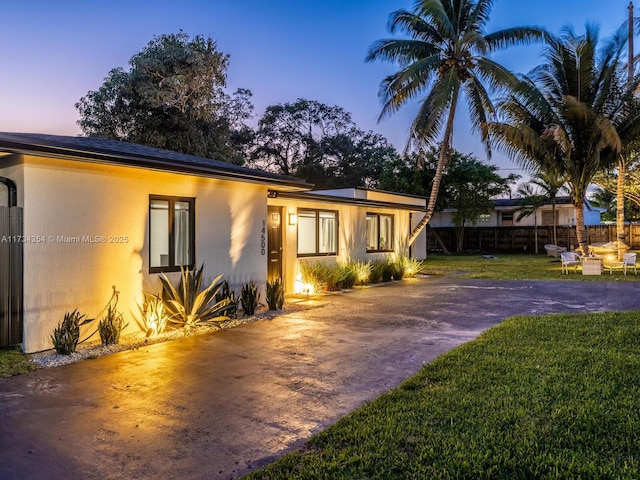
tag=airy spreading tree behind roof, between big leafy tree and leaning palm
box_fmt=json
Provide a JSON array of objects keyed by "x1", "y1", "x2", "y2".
[{"x1": 251, "y1": 99, "x2": 397, "y2": 188}]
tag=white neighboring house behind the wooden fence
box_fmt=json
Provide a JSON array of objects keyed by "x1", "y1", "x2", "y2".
[{"x1": 429, "y1": 197, "x2": 606, "y2": 228}]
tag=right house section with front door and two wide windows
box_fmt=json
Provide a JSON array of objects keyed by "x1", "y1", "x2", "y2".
[{"x1": 268, "y1": 188, "x2": 426, "y2": 292}]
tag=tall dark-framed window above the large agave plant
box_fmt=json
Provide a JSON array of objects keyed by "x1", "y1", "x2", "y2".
[{"x1": 149, "y1": 195, "x2": 195, "y2": 273}]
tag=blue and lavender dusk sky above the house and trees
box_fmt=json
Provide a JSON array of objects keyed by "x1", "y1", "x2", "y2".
[{"x1": 0, "y1": 0, "x2": 640, "y2": 175}]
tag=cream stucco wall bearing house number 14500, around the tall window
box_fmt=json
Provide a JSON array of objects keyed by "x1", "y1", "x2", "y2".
[{"x1": 16, "y1": 157, "x2": 267, "y2": 352}]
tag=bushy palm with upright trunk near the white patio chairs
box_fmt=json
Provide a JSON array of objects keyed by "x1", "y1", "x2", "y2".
[{"x1": 490, "y1": 25, "x2": 635, "y2": 253}]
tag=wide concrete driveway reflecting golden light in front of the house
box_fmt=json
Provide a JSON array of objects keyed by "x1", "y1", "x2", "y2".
[{"x1": 0, "y1": 278, "x2": 640, "y2": 480}]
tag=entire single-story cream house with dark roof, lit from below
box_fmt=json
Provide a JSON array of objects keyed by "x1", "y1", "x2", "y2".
[{"x1": 0, "y1": 133, "x2": 425, "y2": 352}]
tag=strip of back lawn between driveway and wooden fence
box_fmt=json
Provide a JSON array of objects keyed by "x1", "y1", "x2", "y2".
[{"x1": 422, "y1": 254, "x2": 640, "y2": 282}]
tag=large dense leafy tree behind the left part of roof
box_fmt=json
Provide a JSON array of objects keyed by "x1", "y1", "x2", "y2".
[{"x1": 76, "y1": 32, "x2": 253, "y2": 163}]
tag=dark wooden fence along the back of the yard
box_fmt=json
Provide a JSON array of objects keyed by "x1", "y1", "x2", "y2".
[{"x1": 426, "y1": 224, "x2": 640, "y2": 253}]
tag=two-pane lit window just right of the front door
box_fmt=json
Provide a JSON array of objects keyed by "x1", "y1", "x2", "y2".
[{"x1": 298, "y1": 210, "x2": 338, "y2": 256}]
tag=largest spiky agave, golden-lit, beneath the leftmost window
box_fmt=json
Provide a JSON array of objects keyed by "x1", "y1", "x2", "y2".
[{"x1": 160, "y1": 265, "x2": 231, "y2": 332}]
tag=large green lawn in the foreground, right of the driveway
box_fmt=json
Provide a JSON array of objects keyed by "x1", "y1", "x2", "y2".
[{"x1": 247, "y1": 313, "x2": 640, "y2": 480}]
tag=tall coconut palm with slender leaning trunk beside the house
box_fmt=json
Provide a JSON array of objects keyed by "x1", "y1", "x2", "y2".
[{"x1": 366, "y1": 0, "x2": 544, "y2": 245}]
